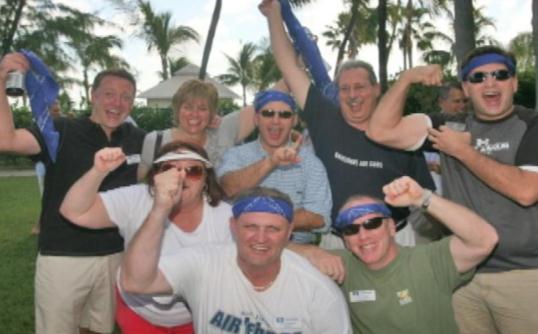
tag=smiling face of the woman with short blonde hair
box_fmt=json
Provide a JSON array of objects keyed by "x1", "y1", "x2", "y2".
[{"x1": 176, "y1": 97, "x2": 213, "y2": 135}]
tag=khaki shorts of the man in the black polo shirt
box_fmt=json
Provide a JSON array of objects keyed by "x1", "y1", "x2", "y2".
[{"x1": 35, "y1": 253, "x2": 121, "y2": 334}]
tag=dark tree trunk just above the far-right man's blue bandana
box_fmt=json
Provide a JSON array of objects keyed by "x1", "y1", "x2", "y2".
[{"x1": 454, "y1": 0, "x2": 475, "y2": 69}]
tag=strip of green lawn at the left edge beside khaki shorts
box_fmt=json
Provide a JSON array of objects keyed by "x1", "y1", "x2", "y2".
[{"x1": 0, "y1": 176, "x2": 40, "y2": 334}]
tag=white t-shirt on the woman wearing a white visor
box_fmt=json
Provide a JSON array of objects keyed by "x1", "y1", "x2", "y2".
[{"x1": 100, "y1": 184, "x2": 232, "y2": 327}]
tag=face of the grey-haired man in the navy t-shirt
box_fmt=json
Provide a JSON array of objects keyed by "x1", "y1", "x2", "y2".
[{"x1": 338, "y1": 67, "x2": 380, "y2": 130}]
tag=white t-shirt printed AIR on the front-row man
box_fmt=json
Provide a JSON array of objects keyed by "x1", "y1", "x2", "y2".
[{"x1": 159, "y1": 244, "x2": 351, "y2": 334}]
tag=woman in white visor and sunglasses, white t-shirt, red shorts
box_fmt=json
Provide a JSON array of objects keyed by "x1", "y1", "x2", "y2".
[{"x1": 60, "y1": 141, "x2": 232, "y2": 334}]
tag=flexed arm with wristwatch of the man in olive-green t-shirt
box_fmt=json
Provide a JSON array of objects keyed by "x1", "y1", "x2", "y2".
[{"x1": 383, "y1": 176, "x2": 499, "y2": 273}]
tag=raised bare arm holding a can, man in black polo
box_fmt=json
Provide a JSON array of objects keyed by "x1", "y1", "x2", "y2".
[{"x1": 0, "y1": 53, "x2": 41, "y2": 155}]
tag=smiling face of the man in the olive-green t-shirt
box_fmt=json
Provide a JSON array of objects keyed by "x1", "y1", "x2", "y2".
[{"x1": 342, "y1": 199, "x2": 398, "y2": 270}]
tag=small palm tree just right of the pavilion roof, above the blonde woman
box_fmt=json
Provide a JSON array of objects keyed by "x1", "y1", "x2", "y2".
[{"x1": 217, "y1": 42, "x2": 257, "y2": 106}]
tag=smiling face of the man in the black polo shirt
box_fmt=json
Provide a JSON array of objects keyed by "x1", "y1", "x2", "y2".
[{"x1": 90, "y1": 75, "x2": 135, "y2": 136}]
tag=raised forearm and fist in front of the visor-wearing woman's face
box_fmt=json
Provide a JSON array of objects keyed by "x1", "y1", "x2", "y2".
[{"x1": 120, "y1": 168, "x2": 185, "y2": 293}]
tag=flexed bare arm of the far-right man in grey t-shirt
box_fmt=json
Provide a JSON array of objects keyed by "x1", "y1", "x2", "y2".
[{"x1": 366, "y1": 65, "x2": 443, "y2": 149}]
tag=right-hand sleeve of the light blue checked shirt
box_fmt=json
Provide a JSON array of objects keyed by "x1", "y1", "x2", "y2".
[{"x1": 303, "y1": 155, "x2": 332, "y2": 233}]
